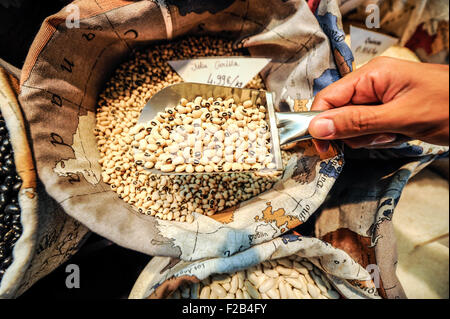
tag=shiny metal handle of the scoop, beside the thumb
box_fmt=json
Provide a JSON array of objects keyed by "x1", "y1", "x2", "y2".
[{"x1": 275, "y1": 111, "x2": 320, "y2": 146}]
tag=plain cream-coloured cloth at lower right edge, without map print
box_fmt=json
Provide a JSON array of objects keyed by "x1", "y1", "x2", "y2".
[{"x1": 393, "y1": 169, "x2": 449, "y2": 298}]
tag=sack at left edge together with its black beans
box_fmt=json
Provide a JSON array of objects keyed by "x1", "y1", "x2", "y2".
[{"x1": 0, "y1": 66, "x2": 87, "y2": 299}]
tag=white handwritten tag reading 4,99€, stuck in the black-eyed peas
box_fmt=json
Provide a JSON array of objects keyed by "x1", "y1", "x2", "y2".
[{"x1": 169, "y1": 57, "x2": 271, "y2": 88}]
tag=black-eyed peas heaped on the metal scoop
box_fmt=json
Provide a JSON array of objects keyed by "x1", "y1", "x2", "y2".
[{"x1": 130, "y1": 96, "x2": 275, "y2": 173}]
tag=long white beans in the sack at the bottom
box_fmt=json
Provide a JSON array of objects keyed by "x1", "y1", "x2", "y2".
[{"x1": 169, "y1": 255, "x2": 340, "y2": 299}]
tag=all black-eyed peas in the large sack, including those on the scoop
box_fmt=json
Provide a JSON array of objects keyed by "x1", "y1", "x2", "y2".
[{"x1": 95, "y1": 37, "x2": 312, "y2": 223}]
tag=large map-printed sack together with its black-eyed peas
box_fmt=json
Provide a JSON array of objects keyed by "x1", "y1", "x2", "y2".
[{"x1": 19, "y1": 0, "x2": 446, "y2": 296}]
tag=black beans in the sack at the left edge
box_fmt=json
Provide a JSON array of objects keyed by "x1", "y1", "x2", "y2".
[{"x1": 0, "y1": 114, "x2": 22, "y2": 281}]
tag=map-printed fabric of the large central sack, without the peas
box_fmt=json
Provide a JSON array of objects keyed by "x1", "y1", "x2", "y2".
[{"x1": 16, "y1": 0, "x2": 446, "y2": 300}]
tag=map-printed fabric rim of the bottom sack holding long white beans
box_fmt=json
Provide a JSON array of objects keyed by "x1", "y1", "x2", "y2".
[{"x1": 129, "y1": 238, "x2": 380, "y2": 299}]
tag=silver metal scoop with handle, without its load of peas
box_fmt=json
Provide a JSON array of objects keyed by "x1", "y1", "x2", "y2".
[{"x1": 136, "y1": 82, "x2": 320, "y2": 175}]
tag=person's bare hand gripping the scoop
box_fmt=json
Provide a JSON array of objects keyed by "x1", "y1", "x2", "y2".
[{"x1": 309, "y1": 57, "x2": 449, "y2": 152}]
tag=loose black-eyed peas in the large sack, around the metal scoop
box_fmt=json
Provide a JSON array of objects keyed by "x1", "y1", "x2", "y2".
[{"x1": 94, "y1": 37, "x2": 288, "y2": 222}]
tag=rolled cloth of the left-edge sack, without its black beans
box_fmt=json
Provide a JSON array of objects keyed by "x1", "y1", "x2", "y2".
[{"x1": 0, "y1": 63, "x2": 87, "y2": 299}]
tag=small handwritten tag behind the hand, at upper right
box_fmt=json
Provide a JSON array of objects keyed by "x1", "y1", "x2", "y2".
[{"x1": 350, "y1": 26, "x2": 398, "y2": 66}]
